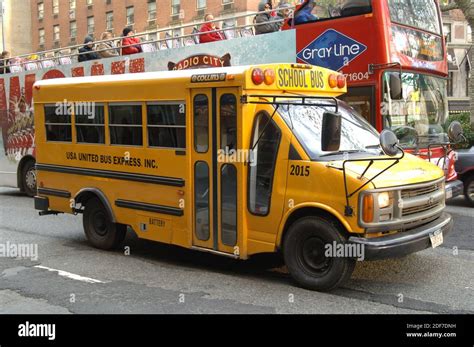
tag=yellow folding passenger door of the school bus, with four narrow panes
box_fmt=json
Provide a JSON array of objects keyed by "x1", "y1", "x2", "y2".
[{"x1": 191, "y1": 88, "x2": 243, "y2": 255}]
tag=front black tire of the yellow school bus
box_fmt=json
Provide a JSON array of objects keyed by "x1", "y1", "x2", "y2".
[{"x1": 283, "y1": 216, "x2": 356, "y2": 291}]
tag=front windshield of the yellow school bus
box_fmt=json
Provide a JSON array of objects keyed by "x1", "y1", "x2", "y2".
[{"x1": 278, "y1": 100, "x2": 380, "y2": 160}]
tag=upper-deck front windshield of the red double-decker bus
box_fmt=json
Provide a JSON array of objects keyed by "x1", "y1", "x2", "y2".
[{"x1": 388, "y1": 0, "x2": 441, "y2": 35}]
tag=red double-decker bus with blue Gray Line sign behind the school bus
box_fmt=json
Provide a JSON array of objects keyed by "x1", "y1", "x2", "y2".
[{"x1": 0, "y1": 0, "x2": 463, "y2": 199}]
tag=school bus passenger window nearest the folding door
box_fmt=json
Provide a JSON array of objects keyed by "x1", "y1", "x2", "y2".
[{"x1": 147, "y1": 102, "x2": 186, "y2": 149}]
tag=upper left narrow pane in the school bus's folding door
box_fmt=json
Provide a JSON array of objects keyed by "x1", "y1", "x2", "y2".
[{"x1": 194, "y1": 94, "x2": 209, "y2": 153}]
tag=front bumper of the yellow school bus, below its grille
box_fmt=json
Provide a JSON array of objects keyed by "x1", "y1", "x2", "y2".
[{"x1": 349, "y1": 213, "x2": 453, "y2": 260}]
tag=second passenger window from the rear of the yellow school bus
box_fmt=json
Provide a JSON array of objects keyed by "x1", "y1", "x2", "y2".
[{"x1": 75, "y1": 104, "x2": 105, "y2": 144}]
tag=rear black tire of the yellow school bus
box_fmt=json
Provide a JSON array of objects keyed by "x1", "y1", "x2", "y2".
[{"x1": 82, "y1": 198, "x2": 127, "y2": 250}]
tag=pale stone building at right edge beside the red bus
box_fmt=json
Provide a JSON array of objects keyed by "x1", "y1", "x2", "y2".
[{"x1": 443, "y1": 10, "x2": 472, "y2": 113}]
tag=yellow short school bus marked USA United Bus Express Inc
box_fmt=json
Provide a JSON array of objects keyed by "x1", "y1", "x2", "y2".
[{"x1": 34, "y1": 64, "x2": 452, "y2": 291}]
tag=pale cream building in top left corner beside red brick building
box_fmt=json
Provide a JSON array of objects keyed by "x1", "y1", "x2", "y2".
[{"x1": 0, "y1": 0, "x2": 35, "y2": 55}]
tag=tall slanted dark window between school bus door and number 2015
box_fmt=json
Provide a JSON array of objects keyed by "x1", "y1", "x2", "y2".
[{"x1": 248, "y1": 112, "x2": 281, "y2": 216}]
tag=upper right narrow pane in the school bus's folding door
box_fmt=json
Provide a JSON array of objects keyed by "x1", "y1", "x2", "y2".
[{"x1": 220, "y1": 94, "x2": 237, "y2": 150}]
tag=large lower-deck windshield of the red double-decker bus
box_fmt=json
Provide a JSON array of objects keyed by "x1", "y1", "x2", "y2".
[{"x1": 382, "y1": 72, "x2": 447, "y2": 148}]
